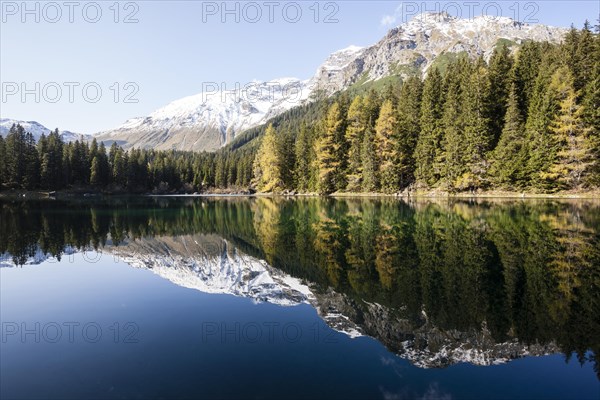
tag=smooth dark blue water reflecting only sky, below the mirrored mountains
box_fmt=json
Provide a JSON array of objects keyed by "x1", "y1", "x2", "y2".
[{"x1": 0, "y1": 198, "x2": 600, "y2": 399}]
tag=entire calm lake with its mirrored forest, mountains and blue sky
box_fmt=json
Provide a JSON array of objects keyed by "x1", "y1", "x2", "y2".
[{"x1": 0, "y1": 197, "x2": 600, "y2": 399}]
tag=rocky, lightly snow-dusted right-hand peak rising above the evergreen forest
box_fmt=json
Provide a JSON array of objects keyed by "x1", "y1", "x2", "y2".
[{"x1": 313, "y1": 13, "x2": 567, "y2": 94}]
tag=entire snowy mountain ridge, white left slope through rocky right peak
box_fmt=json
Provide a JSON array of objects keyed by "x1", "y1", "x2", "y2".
[{"x1": 91, "y1": 13, "x2": 566, "y2": 151}]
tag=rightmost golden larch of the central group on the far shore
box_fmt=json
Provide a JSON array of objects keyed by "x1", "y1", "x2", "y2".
[{"x1": 375, "y1": 99, "x2": 398, "y2": 193}]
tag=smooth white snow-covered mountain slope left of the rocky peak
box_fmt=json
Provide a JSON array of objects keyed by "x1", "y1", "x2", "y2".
[{"x1": 97, "y1": 78, "x2": 309, "y2": 150}]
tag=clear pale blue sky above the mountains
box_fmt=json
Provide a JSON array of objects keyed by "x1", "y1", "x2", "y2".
[{"x1": 0, "y1": 0, "x2": 600, "y2": 133}]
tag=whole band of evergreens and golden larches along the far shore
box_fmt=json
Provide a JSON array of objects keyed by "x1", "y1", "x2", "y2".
[{"x1": 0, "y1": 23, "x2": 600, "y2": 194}]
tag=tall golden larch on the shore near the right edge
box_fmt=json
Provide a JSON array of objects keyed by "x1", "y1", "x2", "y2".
[{"x1": 543, "y1": 68, "x2": 595, "y2": 189}]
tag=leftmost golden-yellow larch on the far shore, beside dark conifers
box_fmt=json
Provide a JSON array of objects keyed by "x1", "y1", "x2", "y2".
[{"x1": 254, "y1": 124, "x2": 284, "y2": 193}]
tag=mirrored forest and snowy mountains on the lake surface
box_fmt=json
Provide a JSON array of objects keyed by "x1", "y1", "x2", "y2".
[{"x1": 0, "y1": 198, "x2": 600, "y2": 373}]
